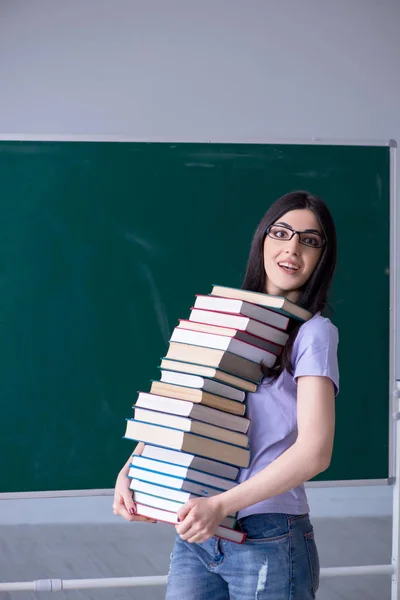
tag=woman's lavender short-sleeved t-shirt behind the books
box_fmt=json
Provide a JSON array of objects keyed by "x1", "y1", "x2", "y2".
[{"x1": 238, "y1": 313, "x2": 339, "y2": 518}]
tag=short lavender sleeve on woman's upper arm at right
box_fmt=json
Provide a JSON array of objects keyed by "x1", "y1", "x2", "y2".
[{"x1": 293, "y1": 315, "x2": 339, "y2": 396}]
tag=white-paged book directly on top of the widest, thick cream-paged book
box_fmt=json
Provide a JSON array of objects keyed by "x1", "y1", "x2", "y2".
[{"x1": 133, "y1": 405, "x2": 249, "y2": 448}]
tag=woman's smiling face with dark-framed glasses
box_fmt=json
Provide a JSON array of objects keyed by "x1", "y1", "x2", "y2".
[{"x1": 264, "y1": 208, "x2": 323, "y2": 302}]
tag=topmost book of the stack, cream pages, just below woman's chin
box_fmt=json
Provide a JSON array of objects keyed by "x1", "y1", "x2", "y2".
[{"x1": 211, "y1": 285, "x2": 312, "y2": 321}]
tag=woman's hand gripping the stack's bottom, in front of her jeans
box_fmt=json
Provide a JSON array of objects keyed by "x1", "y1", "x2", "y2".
[{"x1": 175, "y1": 496, "x2": 226, "y2": 544}]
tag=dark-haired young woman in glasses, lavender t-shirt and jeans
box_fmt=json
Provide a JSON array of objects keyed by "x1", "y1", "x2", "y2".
[{"x1": 114, "y1": 191, "x2": 339, "y2": 600}]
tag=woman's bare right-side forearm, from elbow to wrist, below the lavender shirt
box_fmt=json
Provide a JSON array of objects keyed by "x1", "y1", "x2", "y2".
[{"x1": 214, "y1": 442, "x2": 328, "y2": 516}]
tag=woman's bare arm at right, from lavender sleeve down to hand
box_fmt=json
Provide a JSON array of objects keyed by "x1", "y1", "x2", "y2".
[{"x1": 177, "y1": 376, "x2": 335, "y2": 542}]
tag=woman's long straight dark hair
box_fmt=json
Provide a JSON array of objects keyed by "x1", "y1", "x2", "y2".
[{"x1": 242, "y1": 191, "x2": 336, "y2": 379}]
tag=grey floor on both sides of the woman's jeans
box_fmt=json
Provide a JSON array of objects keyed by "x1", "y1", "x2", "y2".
[{"x1": 0, "y1": 518, "x2": 391, "y2": 600}]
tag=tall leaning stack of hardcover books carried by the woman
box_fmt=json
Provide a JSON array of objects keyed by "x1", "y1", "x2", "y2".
[{"x1": 125, "y1": 286, "x2": 311, "y2": 543}]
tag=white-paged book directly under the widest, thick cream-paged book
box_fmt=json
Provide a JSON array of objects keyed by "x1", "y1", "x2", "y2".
[{"x1": 141, "y1": 444, "x2": 239, "y2": 480}]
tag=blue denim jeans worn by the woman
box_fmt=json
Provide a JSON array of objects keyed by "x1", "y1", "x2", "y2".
[{"x1": 166, "y1": 513, "x2": 319, "y2": 600}]
